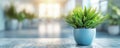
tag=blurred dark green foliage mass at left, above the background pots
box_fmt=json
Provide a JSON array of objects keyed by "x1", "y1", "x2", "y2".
[{"x1": 4, "y1": 4, "x2": 37, "y2": 22}]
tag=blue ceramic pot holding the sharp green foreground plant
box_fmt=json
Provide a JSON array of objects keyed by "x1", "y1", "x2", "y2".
[{"x1": 74, "y1": 28, "x2": 96, "y2": 46}]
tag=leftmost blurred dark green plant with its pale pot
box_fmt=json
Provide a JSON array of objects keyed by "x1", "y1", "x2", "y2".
[{"x1": 4, "y1": 4, "x2": 18, "y2": 30}]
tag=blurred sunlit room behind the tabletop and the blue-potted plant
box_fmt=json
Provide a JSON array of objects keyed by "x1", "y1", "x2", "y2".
[{"x1": 0, "y1": 0, "x2": 120, "y2": 47}]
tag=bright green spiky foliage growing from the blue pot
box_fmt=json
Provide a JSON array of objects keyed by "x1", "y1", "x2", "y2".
[{"x1": 65, "y1": 7, "x2": 106, "y2": 28}]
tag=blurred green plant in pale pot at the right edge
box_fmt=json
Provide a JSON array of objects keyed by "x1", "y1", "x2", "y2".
[{"x1": 108, "y1": 6, "x2": 120, "y2": 35}]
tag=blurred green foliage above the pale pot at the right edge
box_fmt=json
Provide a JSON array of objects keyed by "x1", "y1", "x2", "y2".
[{"x1": 108, "y1": 0, "x2": 120, "y2": 25}]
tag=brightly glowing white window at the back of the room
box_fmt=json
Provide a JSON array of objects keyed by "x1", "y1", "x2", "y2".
[{"x1": 39, "y1": 3, "x2": 60, "y2": 18}]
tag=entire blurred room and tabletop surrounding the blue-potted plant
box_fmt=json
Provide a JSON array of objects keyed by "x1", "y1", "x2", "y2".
[{"x1": 0, "y1": 0, "x2": 120, "y2": 48}]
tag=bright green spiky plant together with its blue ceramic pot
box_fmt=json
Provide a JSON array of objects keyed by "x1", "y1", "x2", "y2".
[{"x1": 65, "y1": 7, "x2": 106, "y2": 46}]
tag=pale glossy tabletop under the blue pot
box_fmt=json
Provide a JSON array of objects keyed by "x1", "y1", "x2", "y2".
[{"x1": 0, "y1": 38, "x2": 120, "y2": 48}]
